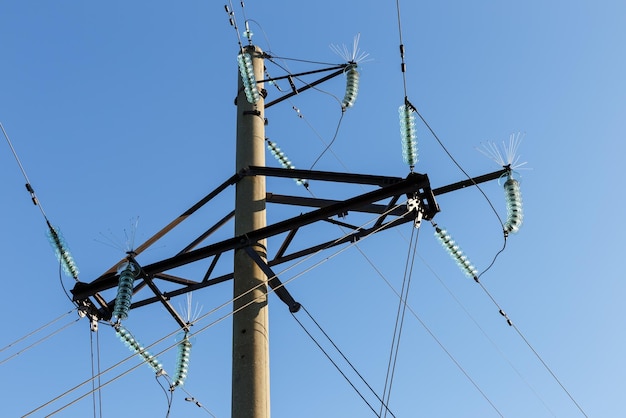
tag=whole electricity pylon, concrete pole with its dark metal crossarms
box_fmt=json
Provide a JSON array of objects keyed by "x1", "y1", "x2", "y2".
[{"x1": 72, "y1": 40, "x2": 510, "y2": 418}]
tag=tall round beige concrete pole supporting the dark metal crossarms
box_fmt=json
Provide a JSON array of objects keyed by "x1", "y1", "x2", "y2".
[{"x1": 232, "y1": 46, "x2": 270, "y2": 418}]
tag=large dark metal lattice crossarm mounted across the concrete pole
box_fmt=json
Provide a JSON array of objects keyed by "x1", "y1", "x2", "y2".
[{"x1": 72, "y1": 166, "x2": 506, "y2": 323}]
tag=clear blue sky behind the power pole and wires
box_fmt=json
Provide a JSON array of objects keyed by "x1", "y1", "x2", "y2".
[{"x1": 0, "y1": 0, "x2": 626, "y2": 418}]
